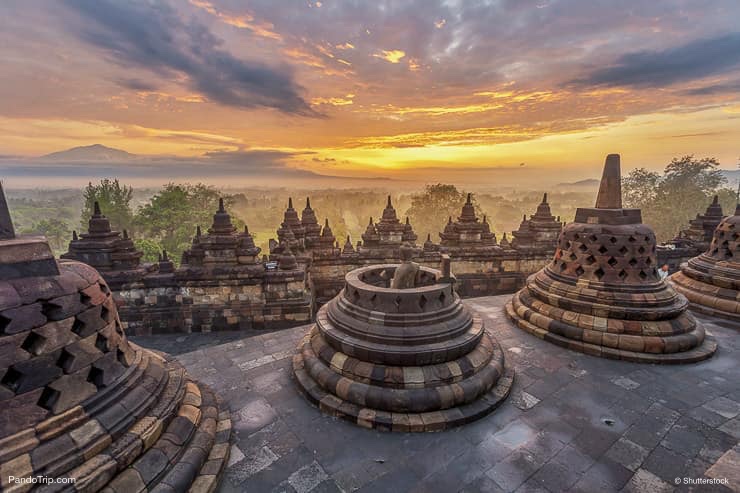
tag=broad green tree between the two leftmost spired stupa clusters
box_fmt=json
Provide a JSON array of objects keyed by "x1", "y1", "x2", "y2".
[{"x1": 136, "y1": 183, "x2": 243, "y2": 261}]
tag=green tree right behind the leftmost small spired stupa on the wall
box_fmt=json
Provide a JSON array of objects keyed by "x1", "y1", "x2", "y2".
[{"x1": 80, "y1": 178, "x2": 134, "y2": 231}]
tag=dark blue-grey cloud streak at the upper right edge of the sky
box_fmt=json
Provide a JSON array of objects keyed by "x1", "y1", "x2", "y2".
[{"x1": 574, "y1": 33, "x2": 740, "y2": 88}]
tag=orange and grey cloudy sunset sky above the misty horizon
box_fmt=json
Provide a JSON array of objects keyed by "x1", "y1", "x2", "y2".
[{"x1": 0, "y1": 0, "x2": 740, "y2": 186}]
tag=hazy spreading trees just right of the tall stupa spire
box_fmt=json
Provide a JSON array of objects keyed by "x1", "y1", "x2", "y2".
[{"x1": 622, "y1": 155, "x2": 731, "y2": 241}]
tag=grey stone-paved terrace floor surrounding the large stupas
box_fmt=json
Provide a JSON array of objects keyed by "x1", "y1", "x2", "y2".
[{"x1": 134, "y1": 296, "x2": 740, "y2": 493}]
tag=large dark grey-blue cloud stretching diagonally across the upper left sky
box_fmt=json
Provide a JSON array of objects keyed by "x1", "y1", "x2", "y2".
[{"x1": 64, "y1": 0, "x2": 318, "y2": 116}]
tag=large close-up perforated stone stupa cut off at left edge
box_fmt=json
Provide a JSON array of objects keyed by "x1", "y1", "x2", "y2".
[{"x1": 0, "y1": 184, "x2": 231, "y2": 493}]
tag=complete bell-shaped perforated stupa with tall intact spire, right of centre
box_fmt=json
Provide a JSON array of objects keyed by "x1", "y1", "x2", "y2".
[{"x1": 507, "y1": 154, "x2": 717, "y2": 363}]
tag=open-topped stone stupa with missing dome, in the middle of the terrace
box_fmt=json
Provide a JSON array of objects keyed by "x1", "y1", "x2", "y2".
[{"x1": 293, "y1": 259, "x2": 513, "y2": 432}]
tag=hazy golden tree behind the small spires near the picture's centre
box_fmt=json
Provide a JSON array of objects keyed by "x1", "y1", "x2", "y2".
[{"x1": 402, "y1": 183, "x2": 482, "y2": 242}]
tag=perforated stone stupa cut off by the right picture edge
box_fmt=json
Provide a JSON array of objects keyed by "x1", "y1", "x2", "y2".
[{"x1": 670, "y1": 204, "x2": 740, "y2": 322}]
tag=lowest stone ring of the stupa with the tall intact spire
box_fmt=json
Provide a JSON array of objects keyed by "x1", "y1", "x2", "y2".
[{"x1": 506, "y1": 295, "x2": 717, "y2": 365}]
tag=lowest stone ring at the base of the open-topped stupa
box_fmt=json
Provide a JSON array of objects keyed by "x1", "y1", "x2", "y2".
[{"x1": 293, "y1": 331, "x2": 514, "y2": 432}]
